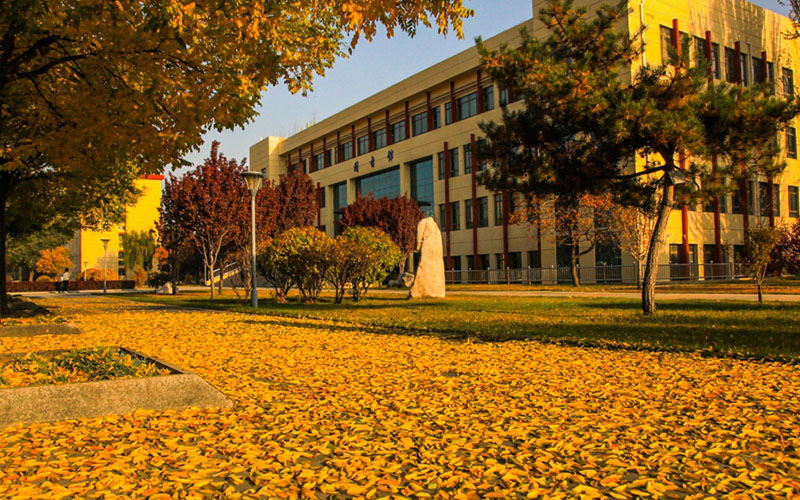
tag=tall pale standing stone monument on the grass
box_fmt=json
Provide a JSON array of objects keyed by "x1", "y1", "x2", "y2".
[{"x1": 409, "y1": 217, "x2": 445, "y2": 298}]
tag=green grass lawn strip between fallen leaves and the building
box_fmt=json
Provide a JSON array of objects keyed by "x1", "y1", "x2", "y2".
[{"x1": 120, "y1": 293, "x2": 800, "y2": 360}]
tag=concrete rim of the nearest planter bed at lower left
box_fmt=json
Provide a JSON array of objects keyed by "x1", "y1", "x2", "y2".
[{"x1": 0, "y1": 347, "x2": 233, "y2": 427}]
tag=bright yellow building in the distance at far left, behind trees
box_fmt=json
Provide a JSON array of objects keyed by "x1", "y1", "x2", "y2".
[{"x1": 68, "y1": 175, "x2": 164, "y2": 279}]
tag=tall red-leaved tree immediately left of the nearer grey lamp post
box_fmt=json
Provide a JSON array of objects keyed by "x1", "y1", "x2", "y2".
[{"x1": 174, "y1": 141, "x2": 250, "y2": 299}]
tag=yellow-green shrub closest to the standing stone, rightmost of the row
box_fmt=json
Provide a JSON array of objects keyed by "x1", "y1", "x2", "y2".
[{"x1": 341, "y1": 226, "x2": 403, "y2": 301}]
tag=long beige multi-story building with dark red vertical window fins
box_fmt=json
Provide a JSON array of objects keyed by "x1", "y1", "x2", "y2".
[{"x1": 250, "y1": 0, "x2": 800, "y2": 282}]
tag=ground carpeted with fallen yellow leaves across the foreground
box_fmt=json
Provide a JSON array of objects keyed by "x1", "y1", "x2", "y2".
[{"x1": 0, "y1": 298, "x2": 800, "y2": 500}]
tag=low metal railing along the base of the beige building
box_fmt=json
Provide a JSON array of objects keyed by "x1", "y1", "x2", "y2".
[{"x1": 445, "y1": 262, "x2": 749, "y2": 285}]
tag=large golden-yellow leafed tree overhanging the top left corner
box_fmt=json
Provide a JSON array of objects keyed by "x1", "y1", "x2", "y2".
[{"x1": 0, "y1": 0, "x2": 471, "y2": 308}]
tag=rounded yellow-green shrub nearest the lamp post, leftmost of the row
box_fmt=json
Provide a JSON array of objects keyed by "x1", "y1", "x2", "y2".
[{"x1": 259, "y1": 227, "x2": 333, "y2": 302}]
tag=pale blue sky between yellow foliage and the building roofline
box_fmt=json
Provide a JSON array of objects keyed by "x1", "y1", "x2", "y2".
[{"x1": 177, "y1": 0, "x2": 788, "y2": 171}]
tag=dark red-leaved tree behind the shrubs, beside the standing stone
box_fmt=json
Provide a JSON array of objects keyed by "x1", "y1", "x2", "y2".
[{"x1": 339, "y1": 193, "x2": 425, "y2": 275}]
